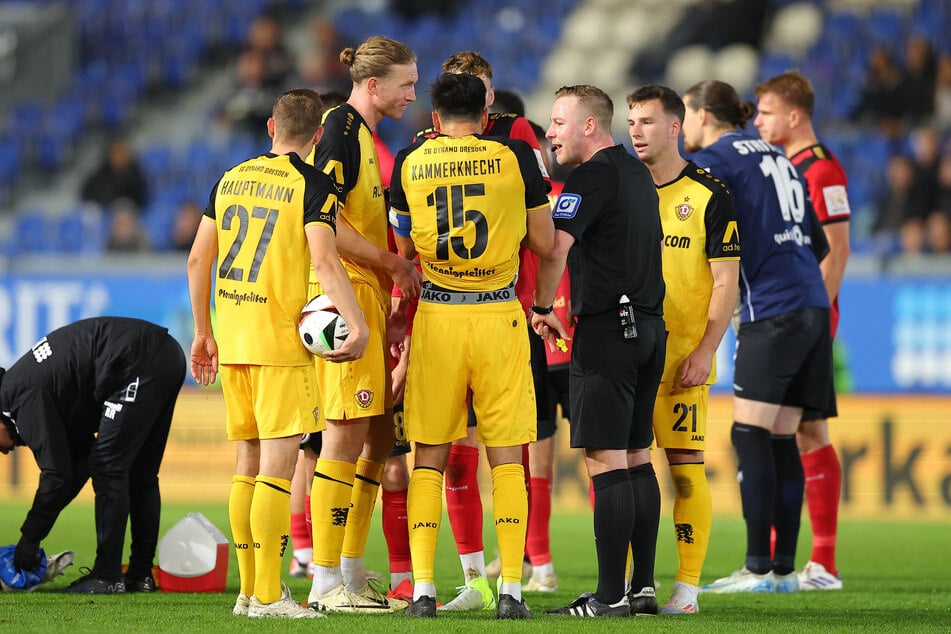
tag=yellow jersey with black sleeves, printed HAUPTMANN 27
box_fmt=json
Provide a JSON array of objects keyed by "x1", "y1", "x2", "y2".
[{"x1": 205, "y1": 154, "x2": 337, "y2": 366}]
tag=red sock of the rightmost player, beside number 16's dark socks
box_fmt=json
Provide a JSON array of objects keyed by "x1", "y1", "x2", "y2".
[{"x1": 802, "y1": 445, "x2": 842, "y2": 575}]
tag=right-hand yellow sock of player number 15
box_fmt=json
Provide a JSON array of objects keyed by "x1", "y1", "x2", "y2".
[{"x1": 492, "y1": 464, "x2": 528, "y2": 583}]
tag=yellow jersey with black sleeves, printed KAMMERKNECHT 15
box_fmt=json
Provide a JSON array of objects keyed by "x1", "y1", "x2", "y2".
[{"x1": 390, "y1": 135, "x2": 548, "y2": 291}]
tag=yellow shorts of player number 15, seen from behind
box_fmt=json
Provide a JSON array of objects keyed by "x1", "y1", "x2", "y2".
[{"x1": 404, "y1": 302, "x2": 536, "y2": 447}]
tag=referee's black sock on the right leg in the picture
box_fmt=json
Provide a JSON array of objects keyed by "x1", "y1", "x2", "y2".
[{"x1": 628, "y1": 462, "x2": 660, "y2": 593}]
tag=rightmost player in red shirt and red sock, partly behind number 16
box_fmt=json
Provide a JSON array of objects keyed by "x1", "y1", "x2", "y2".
[{"x1": 753, "y1": 71, "x2": 851, "y2": 590}]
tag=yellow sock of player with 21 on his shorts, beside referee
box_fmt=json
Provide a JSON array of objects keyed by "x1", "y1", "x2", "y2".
[{"x1": 670, "y1": 464, "x2": 713, "y2": 586}]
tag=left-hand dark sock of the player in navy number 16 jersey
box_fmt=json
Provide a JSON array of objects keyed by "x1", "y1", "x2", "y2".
[{"x1": 730, "y1": 422, "x2": 776, "y2": 574}]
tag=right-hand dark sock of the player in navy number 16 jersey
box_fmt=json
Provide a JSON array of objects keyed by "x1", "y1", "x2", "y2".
[{"x1": 771, "y1": 434, "x2": 806, "y2": 575}]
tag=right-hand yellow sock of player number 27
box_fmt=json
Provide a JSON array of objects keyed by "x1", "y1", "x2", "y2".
[{"x1": 251, "y1": 475, "x2": 291, "y2": 603}]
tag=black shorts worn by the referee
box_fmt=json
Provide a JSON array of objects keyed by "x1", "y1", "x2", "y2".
[{"x1": 569, "y1": 310, "x2": 667, "y2": 450}]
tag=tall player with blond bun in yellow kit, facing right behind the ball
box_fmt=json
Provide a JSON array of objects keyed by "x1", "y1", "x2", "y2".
[{"x1": 308, "y1": 36, "x2": 420, "y2": 613}]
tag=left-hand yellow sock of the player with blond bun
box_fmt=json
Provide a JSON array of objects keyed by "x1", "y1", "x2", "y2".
[{"x1": 310, "y1": 458, "x2": 356, "y2": 568}]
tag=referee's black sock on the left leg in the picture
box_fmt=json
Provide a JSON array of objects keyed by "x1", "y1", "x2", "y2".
[{"x1": 591, "y1": 469, "x2": 634, "y2": 605}]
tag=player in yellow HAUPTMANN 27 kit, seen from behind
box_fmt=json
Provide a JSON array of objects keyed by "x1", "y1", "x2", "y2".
[{"x1": 188, "y1": 89, "x2": 369, "y2": 618}]
